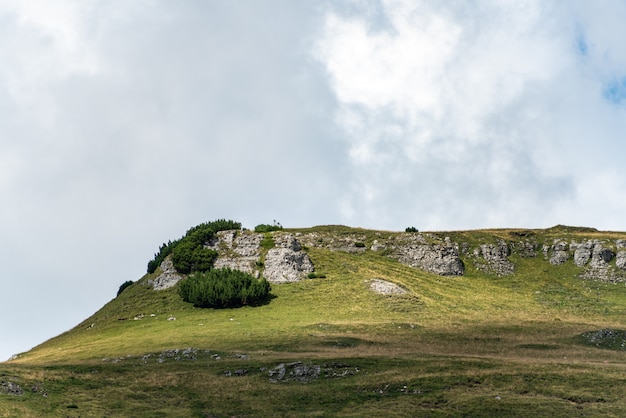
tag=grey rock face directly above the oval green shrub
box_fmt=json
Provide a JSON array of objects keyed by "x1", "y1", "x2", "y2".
[{"x1": 207, "y1": 230, "x2": 263, "y2": 275}]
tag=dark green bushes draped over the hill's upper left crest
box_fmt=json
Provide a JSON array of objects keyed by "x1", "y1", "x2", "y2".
[{"x1": 148, "y1": 219, "x2": 241, "y2": 274}]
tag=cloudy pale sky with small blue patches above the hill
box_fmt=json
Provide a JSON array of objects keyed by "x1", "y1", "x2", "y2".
[{"x1": 0, "y1": 0, "x2": 626, "y2": 360}]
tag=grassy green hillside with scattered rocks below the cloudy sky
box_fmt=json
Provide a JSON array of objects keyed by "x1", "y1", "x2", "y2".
[{"x1": 0, "y1": 226, "x2": 626, "y2": 417}]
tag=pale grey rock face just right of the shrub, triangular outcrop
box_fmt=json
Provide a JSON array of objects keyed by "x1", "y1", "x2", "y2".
[{"x1": 263, "y1": 234, "x2": 314, "y2": 283}]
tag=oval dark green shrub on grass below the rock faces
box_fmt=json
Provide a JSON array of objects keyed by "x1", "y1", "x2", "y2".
[{"x1": 178, "y1": 268, "x2": 271, "y2": 308}]
